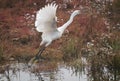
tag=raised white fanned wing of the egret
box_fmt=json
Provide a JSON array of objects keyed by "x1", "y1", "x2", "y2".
[{"x1": 35, "y1": 4, "x2": 58, "y2": 32}]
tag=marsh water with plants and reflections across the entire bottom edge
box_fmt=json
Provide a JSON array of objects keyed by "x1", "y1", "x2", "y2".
[{"x1": 0, "y1": 58, "x2": 120, "y2": 81}]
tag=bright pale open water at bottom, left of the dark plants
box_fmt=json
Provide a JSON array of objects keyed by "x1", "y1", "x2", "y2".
[{"x1": 0, "y1": 63, "x2": 87, "y2": 81}]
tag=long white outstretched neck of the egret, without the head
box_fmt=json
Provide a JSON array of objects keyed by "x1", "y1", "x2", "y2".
[{"x1": 58, "y1": 13, "x2": 77, "y2": 34}]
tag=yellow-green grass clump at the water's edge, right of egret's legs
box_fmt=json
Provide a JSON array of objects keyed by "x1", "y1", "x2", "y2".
[{"x1": 62, "y1": 38, "x2": 80, "y2": 60}]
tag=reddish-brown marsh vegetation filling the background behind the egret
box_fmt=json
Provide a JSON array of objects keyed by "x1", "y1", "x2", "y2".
[{"x1": 0, "y1": 0, "x2": 119, "y2": 63}]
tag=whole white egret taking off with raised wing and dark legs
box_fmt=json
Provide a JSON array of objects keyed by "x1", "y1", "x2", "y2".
[{"x1": 30, "y1": 3, "x2": 80, "y2": 65}]
